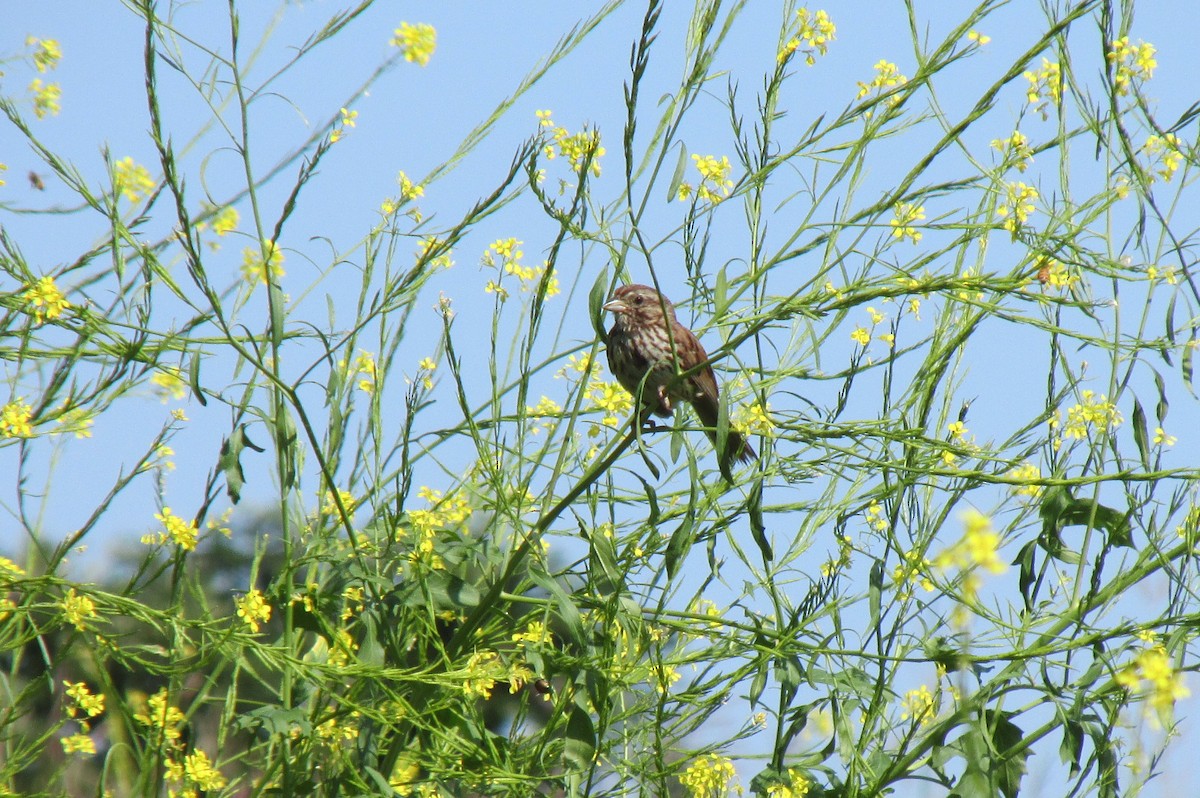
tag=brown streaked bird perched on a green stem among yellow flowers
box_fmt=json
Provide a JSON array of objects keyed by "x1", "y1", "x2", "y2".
[{"x1": 604, "y1": 284, "x2": 757, "y2": 463}]
